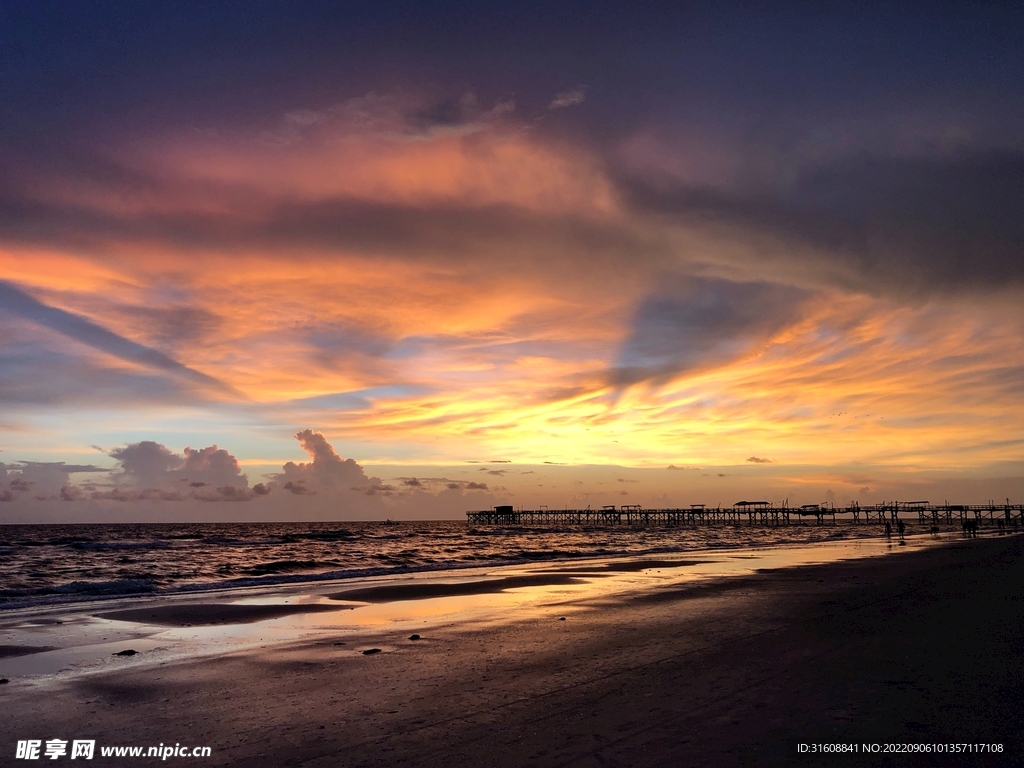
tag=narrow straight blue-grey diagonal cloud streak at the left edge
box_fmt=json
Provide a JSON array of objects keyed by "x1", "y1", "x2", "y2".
[{"x1": 0, "y1": 281, "x2": 240, "y2": 395}]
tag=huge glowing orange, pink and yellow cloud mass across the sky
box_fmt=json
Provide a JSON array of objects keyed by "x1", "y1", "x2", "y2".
[{"x1": 0, "y1": 90, "x2": 1024, "y2": 487}]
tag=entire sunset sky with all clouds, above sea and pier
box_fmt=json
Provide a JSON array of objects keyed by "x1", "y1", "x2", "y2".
[{"x1": 0, "y1": 1, "x2": 1024, "y2": 522}]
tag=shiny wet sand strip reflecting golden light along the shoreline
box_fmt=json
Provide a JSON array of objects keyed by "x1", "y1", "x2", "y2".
[{"x1": 0, "y1": 537, "x2": 939, "y2": 677}]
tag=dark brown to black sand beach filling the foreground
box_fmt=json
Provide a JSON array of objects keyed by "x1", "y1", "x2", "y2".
[{"x1": 0, "y1": 537, "x2": 1024, "y2": 768}]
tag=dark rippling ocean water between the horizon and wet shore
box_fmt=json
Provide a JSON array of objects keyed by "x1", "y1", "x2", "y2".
[{"x1": 0, "y1": 520, "x2": 921, "y2": 609}]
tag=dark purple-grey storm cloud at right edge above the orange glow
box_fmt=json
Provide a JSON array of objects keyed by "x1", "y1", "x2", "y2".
[{"x1": 621, "y1": 152, "x2": 1024, "y2": 295}]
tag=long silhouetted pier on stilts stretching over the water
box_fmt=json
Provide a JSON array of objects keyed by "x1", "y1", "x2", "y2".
[{"x1": 466, "y1": 499, "x2": 1024, "y2": 526}]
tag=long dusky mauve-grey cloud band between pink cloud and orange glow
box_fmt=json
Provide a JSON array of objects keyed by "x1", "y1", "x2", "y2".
[{"x1": 0, "y1": 182, "x2": 655, "y2": 280}]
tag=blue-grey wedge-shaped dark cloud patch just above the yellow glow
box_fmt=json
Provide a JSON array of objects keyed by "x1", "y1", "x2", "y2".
[{"x1": 610, "y1": 279, "x2": 807, "y2": 385}]
